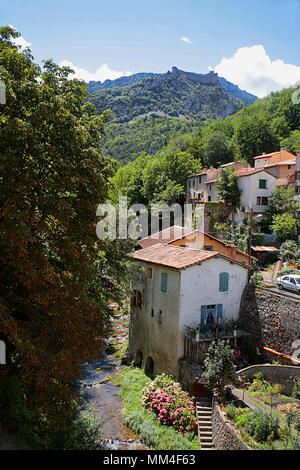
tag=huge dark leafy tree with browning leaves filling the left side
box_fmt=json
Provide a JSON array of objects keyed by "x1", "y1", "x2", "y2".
[{"x1": 0, "y1": 27, "x2": 117, "y2": 418}]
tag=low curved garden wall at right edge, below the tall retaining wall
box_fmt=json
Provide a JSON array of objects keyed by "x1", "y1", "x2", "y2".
[{"x1": 236, "y1": 364, "x2": 300, "y2": 394}]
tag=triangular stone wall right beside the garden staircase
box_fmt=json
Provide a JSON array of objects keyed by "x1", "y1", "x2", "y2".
[{"x1": 212, "y1": 401, "x2": 252, "y2": 450}]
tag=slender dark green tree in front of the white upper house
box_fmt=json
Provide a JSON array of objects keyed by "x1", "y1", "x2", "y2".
[{"x1": 216, "y1": 167, "x2": 242, "y2": 222}]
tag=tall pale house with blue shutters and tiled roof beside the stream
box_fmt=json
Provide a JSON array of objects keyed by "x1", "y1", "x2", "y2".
[{"x1": 128, "y1": 229, "x2": 252, "y2": 375}]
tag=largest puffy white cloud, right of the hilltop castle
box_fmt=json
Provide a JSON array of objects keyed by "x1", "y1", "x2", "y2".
[{"x1": 214, "y1": 45, "x2": 300, "y2": 98}]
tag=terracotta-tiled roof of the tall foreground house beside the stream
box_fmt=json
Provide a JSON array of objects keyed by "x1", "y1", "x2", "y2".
[{"x1": 127, "y1": 243, "x2": 251, "y2": 270}]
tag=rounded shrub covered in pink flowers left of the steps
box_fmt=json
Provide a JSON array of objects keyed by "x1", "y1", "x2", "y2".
[{"x1": 141, "y1": 374, "x2": 197, "y2": 438}]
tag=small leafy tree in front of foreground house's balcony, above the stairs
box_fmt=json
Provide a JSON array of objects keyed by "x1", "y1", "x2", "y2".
[{"x1": 203, "y1": 340, "x2": 234, "y2": 399}]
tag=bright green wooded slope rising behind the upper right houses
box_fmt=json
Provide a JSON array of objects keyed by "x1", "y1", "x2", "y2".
[{"x1": 112, "y1": 88, "x2": 300, "y2": 209}]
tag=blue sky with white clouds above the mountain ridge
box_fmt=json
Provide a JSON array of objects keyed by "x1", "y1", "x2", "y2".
[{"x1": 0, "y1": 0, "x2": 300, "y2": 95}]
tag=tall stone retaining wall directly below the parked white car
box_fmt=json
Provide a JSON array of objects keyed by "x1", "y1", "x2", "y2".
[{"x1": 239, "y1": 286, "x2": 300, "y2": 355}]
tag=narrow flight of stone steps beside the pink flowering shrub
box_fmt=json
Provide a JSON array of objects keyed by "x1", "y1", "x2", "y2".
[{"x1": 196, "y1": 398, "x2": 214, "y2": 450}]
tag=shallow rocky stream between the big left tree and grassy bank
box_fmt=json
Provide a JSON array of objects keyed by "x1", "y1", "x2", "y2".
[{"x1": 79, "y1": 355, "x2": 147, "y2": 450}]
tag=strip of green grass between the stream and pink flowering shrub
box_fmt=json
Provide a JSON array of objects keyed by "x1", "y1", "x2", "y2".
[{"x1": 112, "y1": 367, "x2": 200, "y2": 450}]
